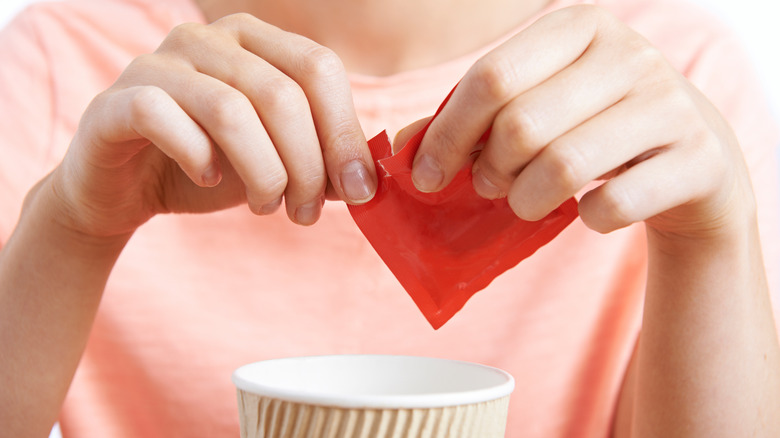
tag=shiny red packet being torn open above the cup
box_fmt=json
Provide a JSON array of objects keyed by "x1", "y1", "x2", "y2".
[{"x1": 349, "y1": 90, "x2": 578, "y2": 329}]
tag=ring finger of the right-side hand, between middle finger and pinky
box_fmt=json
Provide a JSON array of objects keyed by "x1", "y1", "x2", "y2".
[{"x1": 507, "y1": 91, "x2": 685, "y2": 220}]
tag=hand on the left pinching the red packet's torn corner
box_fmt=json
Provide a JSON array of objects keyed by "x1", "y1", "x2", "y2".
[{"x1": 48, "y1": 14, "x2": 376, "y2": 237}]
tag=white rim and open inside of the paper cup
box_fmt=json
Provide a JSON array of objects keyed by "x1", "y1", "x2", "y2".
[{"x1": 232, "y1": 355, "x2": 515, "y2": 409}]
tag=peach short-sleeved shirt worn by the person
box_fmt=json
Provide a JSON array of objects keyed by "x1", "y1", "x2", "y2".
[{"x1": 0, "y1": 0, "x2": 780, "y2": 438}]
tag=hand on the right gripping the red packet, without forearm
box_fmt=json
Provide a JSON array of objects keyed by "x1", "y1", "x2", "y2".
[{"x1": 413, "y1": 6, "x2": 753, "y2": 241}]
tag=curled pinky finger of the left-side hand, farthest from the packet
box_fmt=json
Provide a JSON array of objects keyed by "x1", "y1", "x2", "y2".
[{"x1": 98, "y1": 86, "x2": 221, "y2": 187}]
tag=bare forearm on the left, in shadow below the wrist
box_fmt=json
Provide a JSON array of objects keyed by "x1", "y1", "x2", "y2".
[{"x1": 0, "y1": 177, "x2": 129, "y2": 437}]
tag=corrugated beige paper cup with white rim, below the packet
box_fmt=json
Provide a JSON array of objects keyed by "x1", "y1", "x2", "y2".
[{"x1": 233, "y1": 355, "x2": 514, "y2": 438}]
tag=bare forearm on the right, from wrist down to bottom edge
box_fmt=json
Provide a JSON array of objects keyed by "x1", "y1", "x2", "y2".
[{"x1": 616, "y1": 218, "x2": 780, "y2": 437}]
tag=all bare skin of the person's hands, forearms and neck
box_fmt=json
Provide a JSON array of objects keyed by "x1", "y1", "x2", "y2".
[{"x1": 0, "y1": 0, "x2": 780, "y2": 437}]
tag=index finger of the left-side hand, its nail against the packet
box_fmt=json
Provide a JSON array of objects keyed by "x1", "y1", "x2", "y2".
[{"x1": 216, "y1": 15, "x2": 377, "y2": 203}]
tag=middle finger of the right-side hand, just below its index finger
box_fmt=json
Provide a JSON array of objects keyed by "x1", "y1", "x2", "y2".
[{"x1": 473, "y1": 34, "x2": 639, "y2": 199}]
